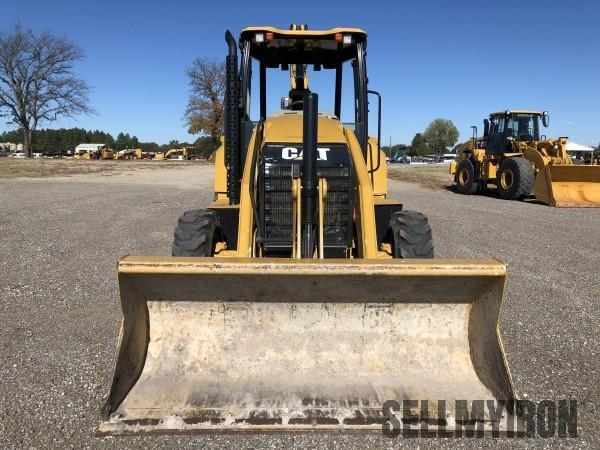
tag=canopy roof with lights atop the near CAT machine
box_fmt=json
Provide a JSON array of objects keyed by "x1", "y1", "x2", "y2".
[{"x1": 240, "y1": 27, "x2": 367, "y2": 69}]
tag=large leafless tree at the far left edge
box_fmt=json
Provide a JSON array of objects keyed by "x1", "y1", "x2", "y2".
[{"x1": 0, "y1": 25, "x2": 93, "y2": 157}]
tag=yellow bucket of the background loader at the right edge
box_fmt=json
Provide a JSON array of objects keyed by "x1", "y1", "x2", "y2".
[{"x1": 533, "y1": 165, "x2": 600, "y2": 208}]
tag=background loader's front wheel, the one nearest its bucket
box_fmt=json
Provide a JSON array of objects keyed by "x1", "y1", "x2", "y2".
[{"x1": 496, "y1": 157, "x2": 535, "y2": 200}]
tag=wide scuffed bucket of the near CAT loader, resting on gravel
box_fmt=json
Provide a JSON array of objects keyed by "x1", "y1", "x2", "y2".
[{"x1": 98, "y1": 257, "x2": 514, "y2": 435}]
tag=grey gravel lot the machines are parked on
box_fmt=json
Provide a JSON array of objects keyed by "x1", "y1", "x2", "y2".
[{"x1": 0, "y1": 162, "x2": 600, "y2": 448}]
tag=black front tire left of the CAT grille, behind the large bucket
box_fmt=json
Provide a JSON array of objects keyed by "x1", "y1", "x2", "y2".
[{"x1": 171, "y1": 209, "x2": 221, "y2": 256}]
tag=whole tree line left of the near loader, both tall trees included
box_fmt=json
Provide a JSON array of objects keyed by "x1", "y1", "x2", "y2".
[{"x1": 0, "y1": 25, "x2": 220, "y2": 158}]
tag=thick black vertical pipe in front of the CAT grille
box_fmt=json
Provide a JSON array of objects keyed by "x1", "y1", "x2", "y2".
[{"x1": 302, "y1": 92, "x2": 319, "y2": 258}]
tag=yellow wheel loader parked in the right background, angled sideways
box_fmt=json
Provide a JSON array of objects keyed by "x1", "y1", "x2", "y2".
[{"x1": 450, "y1": 110, "x2": 600, "y2": 207}]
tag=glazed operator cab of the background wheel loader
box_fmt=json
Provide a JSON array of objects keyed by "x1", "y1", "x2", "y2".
[{"x1": 484, "y1": 110, "x2": 549, "y2": 154}]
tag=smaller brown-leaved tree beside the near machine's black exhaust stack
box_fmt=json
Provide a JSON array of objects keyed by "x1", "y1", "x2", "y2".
[{"x1": 184, "y1": 58, "x2": 225, "y2": 151}]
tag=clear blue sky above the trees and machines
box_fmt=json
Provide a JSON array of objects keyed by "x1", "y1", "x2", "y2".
[{"x1": 0, "y1": 0, "x2": 600, "y2": 145}]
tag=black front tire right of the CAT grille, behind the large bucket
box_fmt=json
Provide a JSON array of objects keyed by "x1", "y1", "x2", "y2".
[{"x1": 386, "y1": 211, "x2": 433, "y2": 258}]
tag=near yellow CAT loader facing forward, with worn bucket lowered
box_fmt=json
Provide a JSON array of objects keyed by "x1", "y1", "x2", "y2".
[{"x1": 98, "y1": 26, "x2": 515, "y2": 435}]
